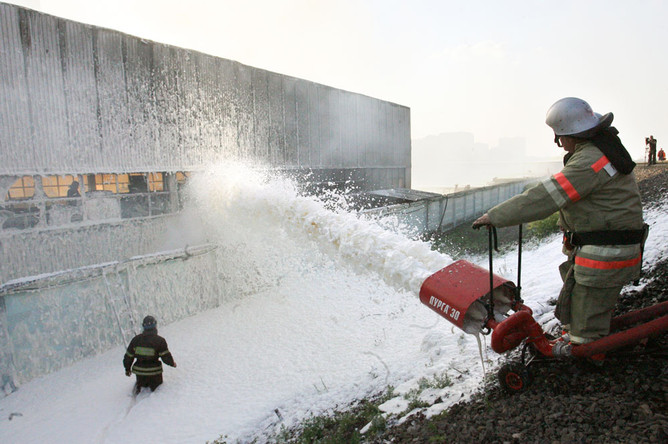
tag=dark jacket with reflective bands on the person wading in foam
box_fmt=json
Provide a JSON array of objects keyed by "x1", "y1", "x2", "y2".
[{"x1": 123, "y1": 330, "x2": 174, "y2": 376}]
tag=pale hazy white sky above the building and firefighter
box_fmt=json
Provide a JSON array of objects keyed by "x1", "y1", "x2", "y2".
[{"x1": 9, "y1": 0, "x2": 668, "y2": 158}]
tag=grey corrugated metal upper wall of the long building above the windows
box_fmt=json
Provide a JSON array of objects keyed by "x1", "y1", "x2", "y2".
[{"x1": 0, "y1": 3, "x2": 410, "y2": 188}]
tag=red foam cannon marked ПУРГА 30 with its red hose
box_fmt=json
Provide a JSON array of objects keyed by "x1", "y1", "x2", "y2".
[{"x1": 420, "y1": 260, "x2": 668, "y2": 358}]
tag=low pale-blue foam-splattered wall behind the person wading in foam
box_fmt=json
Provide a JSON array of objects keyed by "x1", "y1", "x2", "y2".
[{"x1": 0, "y1": 246, "x2": 228, "y2": 390}]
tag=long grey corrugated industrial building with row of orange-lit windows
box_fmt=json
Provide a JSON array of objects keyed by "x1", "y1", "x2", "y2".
[{"x1": 0, "y1": 3, "x2": 410, "y2": 282}]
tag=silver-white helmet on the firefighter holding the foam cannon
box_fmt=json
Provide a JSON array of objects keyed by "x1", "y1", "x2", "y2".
[{"x1": 545, "y1": 97, "x2": 613, "y2": 137}]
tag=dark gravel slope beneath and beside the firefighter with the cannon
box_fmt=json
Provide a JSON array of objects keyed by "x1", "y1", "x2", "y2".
[{"x1": 367, "y1": 164, "x2": 668, "y2": 444}]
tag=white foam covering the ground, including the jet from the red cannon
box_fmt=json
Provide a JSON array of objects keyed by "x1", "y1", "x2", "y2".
[{"x1": 0, "y1": 165, "x2": 668, "y2": 443}]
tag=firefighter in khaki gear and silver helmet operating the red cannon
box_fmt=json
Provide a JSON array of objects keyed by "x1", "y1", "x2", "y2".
[{"x1": 473, "y1": 97, "x2": 647, "y2": 345}]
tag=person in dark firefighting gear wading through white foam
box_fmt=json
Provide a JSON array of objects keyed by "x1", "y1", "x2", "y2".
[{"x1": 123, "y1": 316, "x2": 176, "y2": 394}]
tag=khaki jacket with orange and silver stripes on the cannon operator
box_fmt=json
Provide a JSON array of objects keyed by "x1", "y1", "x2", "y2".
[{"x1": 488, "y1": 142, "x2": 644, "y2": 288}]
